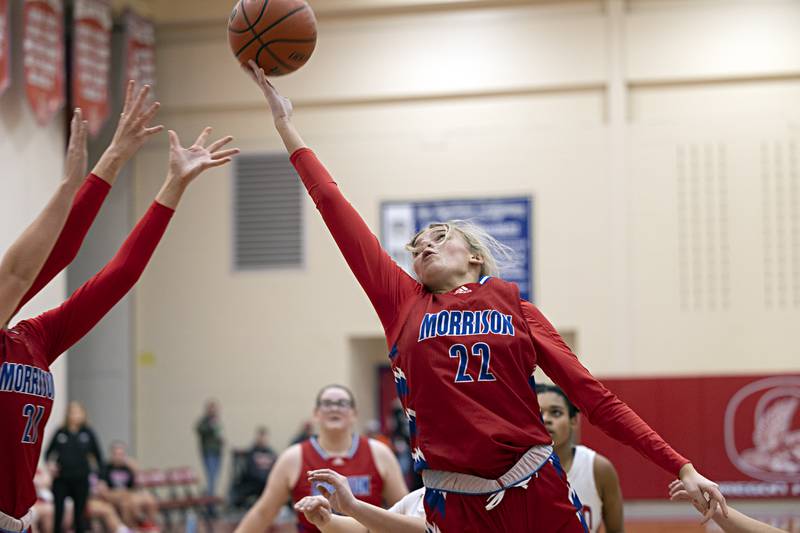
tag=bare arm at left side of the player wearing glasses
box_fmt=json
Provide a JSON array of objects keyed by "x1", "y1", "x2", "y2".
[{"x1": 234, "y1": 444, "x2": 302, "y2": 533}]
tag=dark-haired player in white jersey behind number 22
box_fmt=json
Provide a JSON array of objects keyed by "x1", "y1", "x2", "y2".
[{"x1": 536, "y1": 385, "x2": 623, "y2": 533}]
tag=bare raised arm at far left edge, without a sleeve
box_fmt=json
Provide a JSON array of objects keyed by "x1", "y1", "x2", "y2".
[{"x1": 0, "y1": 109, "x2": 88, "y2": 326}]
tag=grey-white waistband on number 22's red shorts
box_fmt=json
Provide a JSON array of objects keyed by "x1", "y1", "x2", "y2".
[{"x1": 422, "y1": 444, "x2": 553, "y2": 494}]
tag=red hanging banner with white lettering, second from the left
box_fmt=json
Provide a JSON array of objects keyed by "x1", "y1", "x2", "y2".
[{"x1": 22, "y1": 0, "x2": 65, "y2": 126}]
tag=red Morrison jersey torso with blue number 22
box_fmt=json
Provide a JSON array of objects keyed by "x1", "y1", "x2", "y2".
[{"x1": 390, "y1": 277, "x2": 552, "y2": 479}]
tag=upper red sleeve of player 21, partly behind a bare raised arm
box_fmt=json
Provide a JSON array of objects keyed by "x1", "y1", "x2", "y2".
[{"x1": 14, "y1": 174, "x2": 111, "y2": 313}]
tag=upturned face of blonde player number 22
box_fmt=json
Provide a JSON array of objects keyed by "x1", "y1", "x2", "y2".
[{"x1": 412, "y1": 226, "x2": 479, "y2": 291}]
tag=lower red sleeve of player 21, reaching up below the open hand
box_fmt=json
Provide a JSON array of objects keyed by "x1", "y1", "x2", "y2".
[{"x1": 28, "y1": 202, "x2": 174, "y2": 363}]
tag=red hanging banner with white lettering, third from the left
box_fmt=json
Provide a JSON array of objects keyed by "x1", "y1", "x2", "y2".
[{"x1": 72, "y1": 0, "x2": 112, "y2": 136}]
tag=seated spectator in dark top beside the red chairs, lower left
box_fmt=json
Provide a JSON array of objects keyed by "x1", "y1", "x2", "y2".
[{"x1": 98, "y1": 441, "x2": 158, "y2": 530}]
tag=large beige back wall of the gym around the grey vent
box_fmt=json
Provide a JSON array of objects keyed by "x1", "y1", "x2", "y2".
[{"x1": 136, "y1": 0, "x2": 800, "y2": 474}]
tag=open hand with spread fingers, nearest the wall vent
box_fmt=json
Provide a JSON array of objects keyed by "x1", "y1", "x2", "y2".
[{"x1": 169, "y1": 128, "x2": 239, "y2": 184}]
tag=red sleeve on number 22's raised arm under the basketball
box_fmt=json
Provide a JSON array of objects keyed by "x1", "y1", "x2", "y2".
[{"x1": 291, "y1": 148, "x2": 420, "y2": 334}]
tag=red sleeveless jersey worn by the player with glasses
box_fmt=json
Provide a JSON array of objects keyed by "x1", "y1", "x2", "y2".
[{"x1": 292, "y1": 435, "x2": 383, "y2": 533}]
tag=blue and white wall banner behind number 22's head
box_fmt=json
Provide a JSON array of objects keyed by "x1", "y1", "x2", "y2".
[{"x1": 381, "y1": 197, "x2": 534, "y2": 301}]
